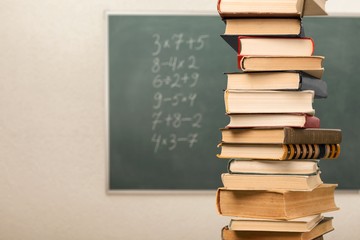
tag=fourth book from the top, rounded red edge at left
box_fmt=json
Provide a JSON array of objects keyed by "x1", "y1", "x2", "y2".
[{"x1": 237, "y1": 55, "x2": 324, "y2": 78}]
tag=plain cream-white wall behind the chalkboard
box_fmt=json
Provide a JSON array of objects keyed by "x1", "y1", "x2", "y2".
[{"x1": 0, "y1": 0, "x2": 360, "y2": 240}]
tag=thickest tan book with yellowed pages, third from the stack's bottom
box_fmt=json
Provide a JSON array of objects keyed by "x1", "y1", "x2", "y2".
[{"x1": 216, "y1": 184, "x2": 338, "y2": 220}]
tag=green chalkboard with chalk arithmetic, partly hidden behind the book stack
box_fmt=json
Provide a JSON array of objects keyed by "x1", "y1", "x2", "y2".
[{"x1": 107, "y1": 14, "x2": 360, "y2": 190}]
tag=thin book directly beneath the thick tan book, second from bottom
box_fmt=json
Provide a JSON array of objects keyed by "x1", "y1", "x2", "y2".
[{"x1": 228, "y1": 214, "x2": 324, "y2": 233}]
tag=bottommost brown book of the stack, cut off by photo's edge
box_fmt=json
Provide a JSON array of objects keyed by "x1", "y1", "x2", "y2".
[{"x1": 221, "y1": 217, "x2": 334, "y2": 240}]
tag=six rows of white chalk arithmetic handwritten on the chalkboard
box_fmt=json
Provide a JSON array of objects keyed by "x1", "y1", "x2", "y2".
[{"x1": 149, "y1": 33, "x2": 209, "y2": 153}]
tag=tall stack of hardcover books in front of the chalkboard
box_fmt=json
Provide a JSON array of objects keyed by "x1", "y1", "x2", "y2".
[{"x1": 216, "y1": 0, "x2": 342, "y2": 240}]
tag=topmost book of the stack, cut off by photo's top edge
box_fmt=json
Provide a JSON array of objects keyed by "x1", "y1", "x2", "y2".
[{"x1": 217, "y1": 0, "x2": 327, "y2": 18}]
